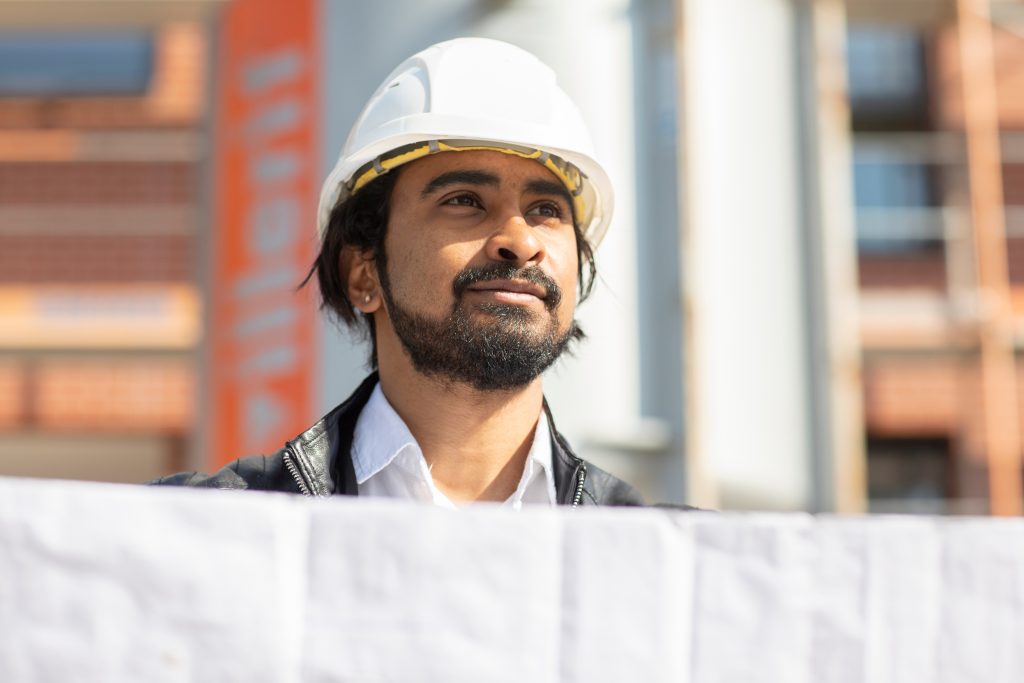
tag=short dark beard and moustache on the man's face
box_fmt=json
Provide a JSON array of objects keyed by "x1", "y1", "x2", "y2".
[{"x1": 381, "y1": 263, "x2": 577, "y2": 391}]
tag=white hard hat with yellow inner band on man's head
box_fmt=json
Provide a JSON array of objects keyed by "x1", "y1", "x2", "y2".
[{"x1": 317, "y1": 38, "x2": 613, "y2": 247}]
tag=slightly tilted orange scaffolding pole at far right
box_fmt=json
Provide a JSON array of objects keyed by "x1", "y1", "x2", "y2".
[{"x1": 957, "y1": 0, "x2": 1024, "y2": 515}]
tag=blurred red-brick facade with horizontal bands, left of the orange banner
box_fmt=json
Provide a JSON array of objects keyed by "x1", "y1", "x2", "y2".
[{"x1": 0, "y1": 2, "x2": 218, "y2": 481}]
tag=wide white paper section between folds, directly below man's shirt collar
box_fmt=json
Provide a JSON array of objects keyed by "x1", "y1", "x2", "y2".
[{"x1": 303, "y1": 499, "x2": 561, "y2": 683}]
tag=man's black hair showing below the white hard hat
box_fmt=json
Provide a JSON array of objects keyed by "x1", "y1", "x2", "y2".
[{"x1": 299, "y1": 168, "x2": 597, "y2": 370}]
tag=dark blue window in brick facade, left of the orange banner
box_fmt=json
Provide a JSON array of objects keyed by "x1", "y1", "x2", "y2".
[{"x1": 0, "y1": 31, "x2": 153, "y2": 97}]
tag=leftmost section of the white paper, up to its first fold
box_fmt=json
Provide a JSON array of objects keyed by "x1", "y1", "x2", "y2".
[{"x1": 0, "y1": 479, "x2": 307, "y2": 682}]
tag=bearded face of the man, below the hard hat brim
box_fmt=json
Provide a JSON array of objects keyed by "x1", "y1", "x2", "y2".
[{"x1": 377, "y1": 151, "x2": 578, "y2": 390}]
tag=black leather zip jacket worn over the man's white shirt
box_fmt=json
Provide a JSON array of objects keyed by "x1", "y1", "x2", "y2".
[{"x1": 153, "y1": 373, "x2": 643, "y2": 507}]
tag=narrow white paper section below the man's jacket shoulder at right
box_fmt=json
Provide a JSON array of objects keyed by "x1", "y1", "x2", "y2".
[{"x1": 558, "y1": 508, "x2": 694, "y2": 683}]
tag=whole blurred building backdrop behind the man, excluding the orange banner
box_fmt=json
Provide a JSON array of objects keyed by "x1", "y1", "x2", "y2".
[{"x1": 6, "y1": 0, "x2": 1024, "y2": 513}]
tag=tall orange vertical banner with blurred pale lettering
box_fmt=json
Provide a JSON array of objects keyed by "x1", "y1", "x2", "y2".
[{"x1": 204, "y1": 0, "x2": 319, "y2": 468}]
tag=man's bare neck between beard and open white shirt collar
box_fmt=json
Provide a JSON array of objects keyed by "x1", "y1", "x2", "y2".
[{"x1": 380, "y1": 359, "x2": 544, "y2": 502}]
